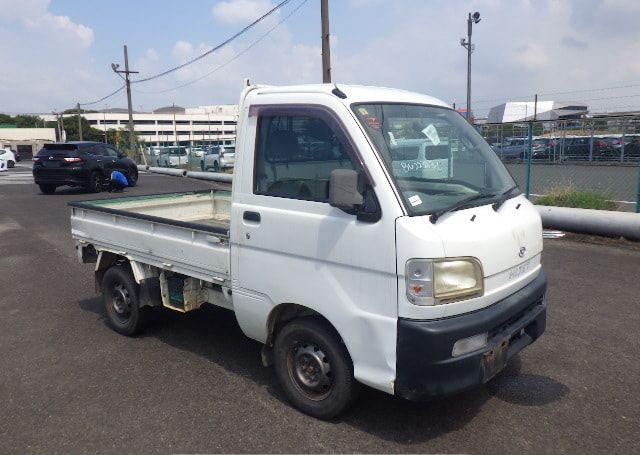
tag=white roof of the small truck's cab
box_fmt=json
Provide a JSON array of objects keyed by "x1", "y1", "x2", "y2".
[{"x1": 248, "y1": 84, "x2": 451, "y2": 107}]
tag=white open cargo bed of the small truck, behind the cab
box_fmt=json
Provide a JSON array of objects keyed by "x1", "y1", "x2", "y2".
[{"x1": 69, "y1": 190, "x2": 231, "y2": 283}]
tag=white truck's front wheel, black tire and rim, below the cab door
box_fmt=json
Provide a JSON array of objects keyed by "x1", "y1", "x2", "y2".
[{"x1": 273, "y1": 318, "x2": 359, "y2": 420}]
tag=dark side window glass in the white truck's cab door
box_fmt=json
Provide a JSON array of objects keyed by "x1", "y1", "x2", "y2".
[{"x1": 254, "y1": 115, "x2": 355, "y2": 202}]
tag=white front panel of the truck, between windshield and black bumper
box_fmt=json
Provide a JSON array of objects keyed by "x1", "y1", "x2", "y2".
[{"x1": 396, "y1": 196, "x2": 542, "y2": 319}]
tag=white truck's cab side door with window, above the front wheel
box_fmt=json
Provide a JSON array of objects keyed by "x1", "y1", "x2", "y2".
[{"x1": 231, "y1": 106, "x2": 397, "y2": 392}]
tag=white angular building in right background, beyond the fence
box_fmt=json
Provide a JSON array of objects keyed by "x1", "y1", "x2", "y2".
[{"x1": 487, "y1": 101, "x2": 589, "y2": 123}]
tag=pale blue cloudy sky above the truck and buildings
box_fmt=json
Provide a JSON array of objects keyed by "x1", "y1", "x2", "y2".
[{"x1": 0, "y1": 0, "x2": 640, "y2": 115}]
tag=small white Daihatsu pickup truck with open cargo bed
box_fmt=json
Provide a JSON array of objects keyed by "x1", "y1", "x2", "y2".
[{"x1": 69, "y1": 84, "x2": 547, "y2": 419}]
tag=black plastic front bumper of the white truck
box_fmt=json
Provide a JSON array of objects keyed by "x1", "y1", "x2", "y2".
[{"x1": 395, "y1": 271, "x2": 547, "y2": 401}]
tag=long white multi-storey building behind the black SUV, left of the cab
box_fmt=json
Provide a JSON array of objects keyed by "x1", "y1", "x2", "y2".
[{"x1": 43, "y1": 105, "x2": 238, "y2": 147}]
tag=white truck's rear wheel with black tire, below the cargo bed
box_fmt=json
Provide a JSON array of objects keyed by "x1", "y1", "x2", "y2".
[{"x1": 102, "y1": 265, "x2": 151, "y2": 336}]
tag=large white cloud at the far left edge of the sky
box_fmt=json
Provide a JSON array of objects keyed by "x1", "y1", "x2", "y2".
[{"x1": 0, "y1": 0, "x2": 96, "y2": 111}]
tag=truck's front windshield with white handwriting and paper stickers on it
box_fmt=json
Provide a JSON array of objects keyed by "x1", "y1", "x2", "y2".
[{"x1": 353, "y1": 104, "x2": 515, "y2": 215}]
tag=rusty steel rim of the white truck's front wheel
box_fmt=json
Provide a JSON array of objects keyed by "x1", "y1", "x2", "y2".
[{"x1": 287, "y1": 342, "x2": 333, "y2": 401}]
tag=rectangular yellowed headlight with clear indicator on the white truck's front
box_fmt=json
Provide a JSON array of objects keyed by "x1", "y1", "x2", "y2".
[{"x1": 405, "y1": 258, "x2": 484, "y2": 305}]
